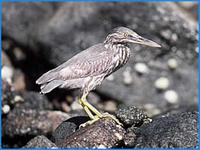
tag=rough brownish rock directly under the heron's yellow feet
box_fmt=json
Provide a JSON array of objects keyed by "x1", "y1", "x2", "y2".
[{"x1": 57, "y1": 118, "x2": 125, "y2": 148}]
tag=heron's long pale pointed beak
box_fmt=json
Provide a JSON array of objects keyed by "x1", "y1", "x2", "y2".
[{"x1": 129, "y1": 35, "x2": 161, "y2": 47}]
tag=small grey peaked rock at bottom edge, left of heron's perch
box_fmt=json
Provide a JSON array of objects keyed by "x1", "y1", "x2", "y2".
[{"x1": 23, "y1": 135, "x2": 58, "y2": 148}]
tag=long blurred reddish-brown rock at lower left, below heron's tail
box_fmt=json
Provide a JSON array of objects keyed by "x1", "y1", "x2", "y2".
[{"x1": 3, "y1": 108, "x2": 69, "y2": 138}]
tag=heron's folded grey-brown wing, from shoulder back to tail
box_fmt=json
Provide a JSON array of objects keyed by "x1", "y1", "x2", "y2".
[{"x1": 36, "y1": 44, "x2": 112, "y2": 84}]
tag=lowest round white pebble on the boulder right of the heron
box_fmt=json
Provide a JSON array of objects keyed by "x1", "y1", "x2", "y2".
[{"x1": 164, "y1": 90, "x2": 178, "y2": 104}]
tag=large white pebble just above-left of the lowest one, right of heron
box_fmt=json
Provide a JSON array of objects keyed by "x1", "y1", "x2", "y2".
[{"x1": 154, "y1": 77, "x2": 169, "y2": 90}]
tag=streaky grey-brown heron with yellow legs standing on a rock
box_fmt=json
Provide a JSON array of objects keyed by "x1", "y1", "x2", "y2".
[{"x1": 36, "y1": 27, "x2": 161, "y2": 124}]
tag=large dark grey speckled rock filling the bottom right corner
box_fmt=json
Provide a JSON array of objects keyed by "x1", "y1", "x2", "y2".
[{"x1": 132, "y1": 112, "x2": 198, "y2": 148}]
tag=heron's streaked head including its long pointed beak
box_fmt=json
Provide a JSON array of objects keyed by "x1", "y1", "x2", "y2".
[{"x1": 105, "y1": 27, "x2": 161, "y2": 47}]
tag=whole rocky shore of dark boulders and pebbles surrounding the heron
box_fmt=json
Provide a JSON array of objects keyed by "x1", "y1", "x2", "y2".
[{"x1": 1, "y1": 2, "x2": 199, "y2": 148}]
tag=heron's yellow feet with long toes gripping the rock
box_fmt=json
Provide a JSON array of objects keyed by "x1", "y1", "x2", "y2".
[{"x1": 79, "y1": 113, "x2": 123, "y2": 128}]
